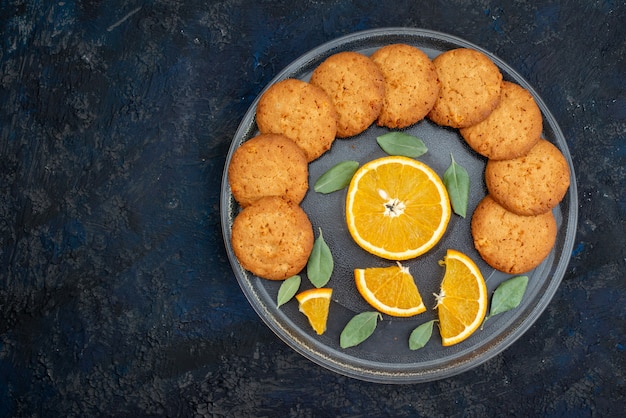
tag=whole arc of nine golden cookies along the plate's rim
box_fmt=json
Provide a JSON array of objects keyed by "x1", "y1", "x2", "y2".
[{"x1": 228, "y1": 44, "x2": 570, "y2": 280}]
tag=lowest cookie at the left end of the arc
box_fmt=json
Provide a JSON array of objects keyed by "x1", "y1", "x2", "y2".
[{"x1": 231, "y1": 197, "x2": 313, "y2": 280}]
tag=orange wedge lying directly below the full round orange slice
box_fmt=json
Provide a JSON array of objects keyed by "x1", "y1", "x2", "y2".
[{"x1": 354, "y1": 263, "x2": 426, "y2": 316}]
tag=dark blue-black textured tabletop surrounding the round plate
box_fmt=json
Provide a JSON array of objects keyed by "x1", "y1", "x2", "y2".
[{"x1": 0, "y1": 0, "x2": 626, "y2": 417}]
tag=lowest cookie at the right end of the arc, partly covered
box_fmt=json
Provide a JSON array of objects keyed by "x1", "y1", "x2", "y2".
[{"x1": 471, "y1": 195, "x2": 557, "y2": 274}]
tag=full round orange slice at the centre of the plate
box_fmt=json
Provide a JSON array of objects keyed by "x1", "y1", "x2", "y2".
[{"x1": 346, "y1": 156, "x2": 451, "y2": 260}]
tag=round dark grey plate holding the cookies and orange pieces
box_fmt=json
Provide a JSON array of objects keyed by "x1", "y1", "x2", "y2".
[{"x1": 221, "y1": 28, "x2": 578, "y2": 383}]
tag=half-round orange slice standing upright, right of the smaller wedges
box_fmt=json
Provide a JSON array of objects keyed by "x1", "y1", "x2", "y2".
[{"x1": 435, "y1": 250, "x2": 487, "y2": 346}]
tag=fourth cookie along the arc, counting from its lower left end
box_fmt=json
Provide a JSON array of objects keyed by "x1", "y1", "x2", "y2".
[{"x1": 310, "y1": 51, "x2": 385, "y2": 138}]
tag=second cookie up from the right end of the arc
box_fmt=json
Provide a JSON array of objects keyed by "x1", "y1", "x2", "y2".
[{"x1": 485, "y1": 139, "x2": 570, "y2": 215}]
